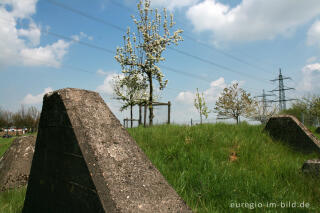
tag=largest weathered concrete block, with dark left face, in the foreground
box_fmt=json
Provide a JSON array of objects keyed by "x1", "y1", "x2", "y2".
[{"x1": 23, "y1": 88, "x2": 191, "y2": 213}]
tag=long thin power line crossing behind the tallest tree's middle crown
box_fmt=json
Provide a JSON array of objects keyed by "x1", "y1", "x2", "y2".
[{"x1": 46, "y1": 0, "x2": 267, "y2": 83}]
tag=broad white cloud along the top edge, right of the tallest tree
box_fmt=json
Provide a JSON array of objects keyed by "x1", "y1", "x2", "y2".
[{"x1": 187, "y1": 0, "x2": 320, "y2": 41}]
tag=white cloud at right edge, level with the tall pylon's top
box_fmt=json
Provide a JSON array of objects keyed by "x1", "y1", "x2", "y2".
[{"x1": 297, "y1": 63, "x2": 320, "y2": 93}]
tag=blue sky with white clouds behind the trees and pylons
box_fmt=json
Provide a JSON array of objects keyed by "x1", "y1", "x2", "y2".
[{"x1": 0, "y1": 0, "x2": 320, "y2": 123}]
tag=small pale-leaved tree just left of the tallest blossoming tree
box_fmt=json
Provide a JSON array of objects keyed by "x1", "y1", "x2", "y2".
[{"x1": 112, "y1": 75, "x2": 148, "y2": 128}]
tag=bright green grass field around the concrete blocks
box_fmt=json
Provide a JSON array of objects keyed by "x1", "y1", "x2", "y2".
[{"x1": 0, "y1": 124, "x2": 320, "y2": 213}]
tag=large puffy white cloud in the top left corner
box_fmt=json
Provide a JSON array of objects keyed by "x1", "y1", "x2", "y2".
[{"x1": 0, "y1": 0, "x2": 84, "y2": 67}]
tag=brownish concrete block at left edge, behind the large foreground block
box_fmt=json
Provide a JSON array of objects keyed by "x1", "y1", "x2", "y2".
[{"x1": 0, "y1": 135, "x2": 36, "y2": 191}]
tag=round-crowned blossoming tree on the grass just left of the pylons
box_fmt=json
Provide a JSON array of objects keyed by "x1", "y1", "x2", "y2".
[{"x1": 214, "y1": 83, "x2": 256, "y2": 124}]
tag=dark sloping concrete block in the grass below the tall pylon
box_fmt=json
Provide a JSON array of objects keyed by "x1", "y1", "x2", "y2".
[{"x1": 265, "y1": 115, "x2": 320, "y2": 152}]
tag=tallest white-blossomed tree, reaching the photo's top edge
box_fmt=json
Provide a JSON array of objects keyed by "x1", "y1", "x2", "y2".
[{"x1": 115, "y1": 0, "x2": 183, "y2": 125}]
